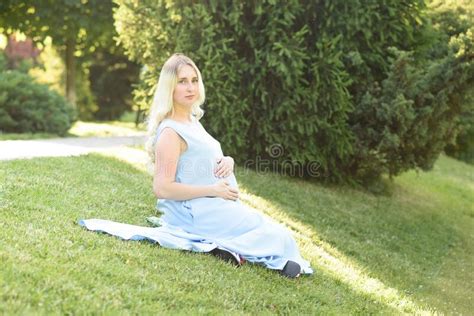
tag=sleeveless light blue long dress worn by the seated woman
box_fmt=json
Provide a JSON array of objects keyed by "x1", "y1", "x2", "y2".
[{"x1": 79, "y1": 119, "x2": 313, "y2": 274}]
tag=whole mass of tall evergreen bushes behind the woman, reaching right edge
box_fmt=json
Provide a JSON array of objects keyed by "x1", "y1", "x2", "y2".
[{"x1": 115, "y1": 0, "x2": 473, "y2": 182}]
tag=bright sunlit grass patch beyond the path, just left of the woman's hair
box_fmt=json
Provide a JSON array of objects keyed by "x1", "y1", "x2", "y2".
[{"x1": 69, "y1": 121, "x2": 144, "y2": 137}]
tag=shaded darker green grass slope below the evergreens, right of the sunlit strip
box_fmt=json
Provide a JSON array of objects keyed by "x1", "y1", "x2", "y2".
[{"x1": 238, "y1": 155, "x2": 473, "y2": 311}]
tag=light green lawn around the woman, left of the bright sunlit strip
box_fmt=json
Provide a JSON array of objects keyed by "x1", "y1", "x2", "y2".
[{"x1": 0, "y1": 155, "x2": 434, "y2": 314}]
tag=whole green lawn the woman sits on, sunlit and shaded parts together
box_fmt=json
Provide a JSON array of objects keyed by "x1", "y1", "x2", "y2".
[{"x1": 0, "y1": 155, "x2": 474, "y2": 315}]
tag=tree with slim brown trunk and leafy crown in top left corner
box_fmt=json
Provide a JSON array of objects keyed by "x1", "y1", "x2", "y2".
[{"x1": 0, "y1": 0, "x2": 115, "y2": 105}]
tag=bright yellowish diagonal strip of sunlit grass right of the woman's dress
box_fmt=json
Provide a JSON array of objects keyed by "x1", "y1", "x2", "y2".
[{"x1": 240, "y1": 188, "x2": 432, "y2": 314}]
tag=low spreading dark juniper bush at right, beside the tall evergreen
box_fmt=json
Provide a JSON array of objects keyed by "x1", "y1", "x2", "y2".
[{"x1": 347, "y1": 41, "x2": 474, "y2": 181}]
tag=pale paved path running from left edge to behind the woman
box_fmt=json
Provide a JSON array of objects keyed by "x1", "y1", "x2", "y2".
[{"x1": 0, "y1": 136, "x2": 145, "y2": 160}]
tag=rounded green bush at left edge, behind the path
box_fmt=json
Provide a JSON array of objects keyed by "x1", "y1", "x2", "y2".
[{"x1": 0, "y1": 71, "x2": 75, "y2": 135}]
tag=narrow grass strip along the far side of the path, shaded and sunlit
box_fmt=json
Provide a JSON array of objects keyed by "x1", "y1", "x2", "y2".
[{"x1": 0, "y1": 121, "x2": 145, "y2": 141}]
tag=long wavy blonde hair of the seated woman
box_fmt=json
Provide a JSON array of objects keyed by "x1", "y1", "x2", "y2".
[{"x1": 145, "y1": 53, "x2": 205, "y2": 171}]
